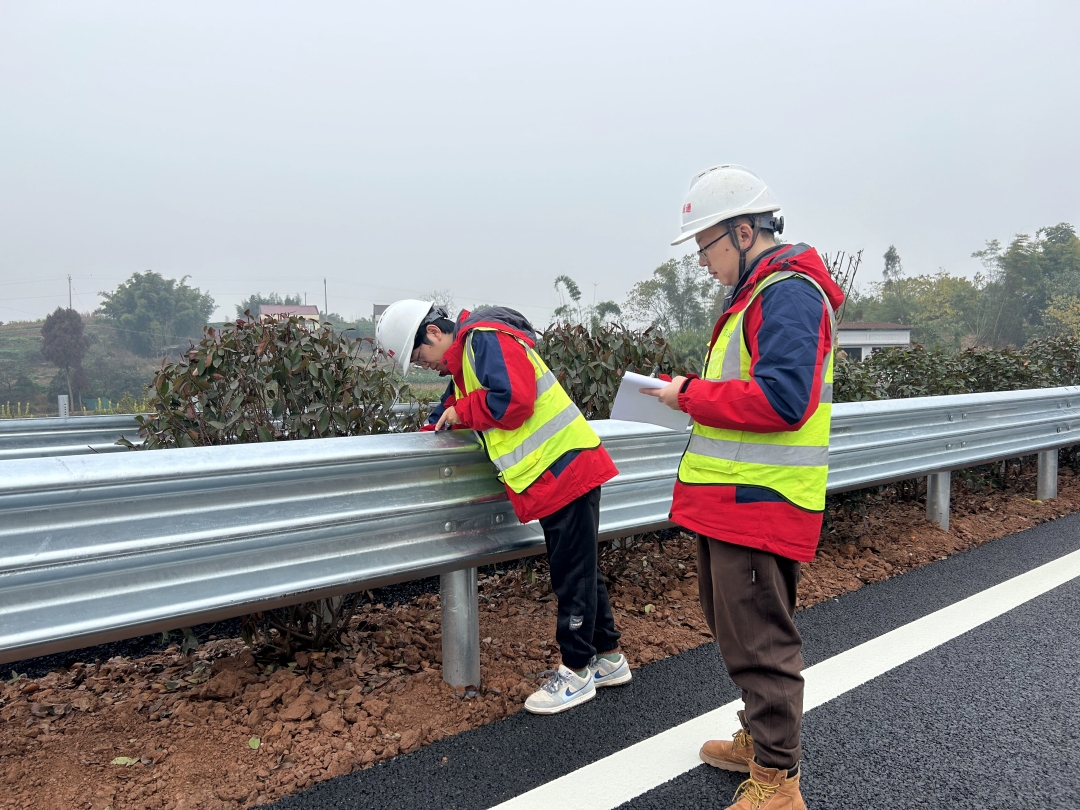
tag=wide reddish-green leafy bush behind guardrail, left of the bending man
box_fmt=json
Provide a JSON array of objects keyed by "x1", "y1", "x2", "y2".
[{"x1": 130, "y1": 318, "x2": 423, "y2": 449}]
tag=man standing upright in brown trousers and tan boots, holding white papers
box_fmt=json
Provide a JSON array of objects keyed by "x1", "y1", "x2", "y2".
[{"x1": 644, "y1": 165, "x2": 843, "y2": 810}]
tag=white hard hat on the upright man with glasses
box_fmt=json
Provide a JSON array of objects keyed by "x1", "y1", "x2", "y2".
[{"x1": 672, "y1": 163, "x2": 783, "y2": 245}]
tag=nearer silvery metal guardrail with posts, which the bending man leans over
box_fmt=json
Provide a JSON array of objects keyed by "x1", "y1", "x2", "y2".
[{"x1": 0, "y1": 388, "x2": 1080, "y2": 684}]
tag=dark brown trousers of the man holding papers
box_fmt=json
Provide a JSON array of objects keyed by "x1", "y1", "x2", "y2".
[{"x1": 698, "y1": 535, "x2": 802, "y2": 768}]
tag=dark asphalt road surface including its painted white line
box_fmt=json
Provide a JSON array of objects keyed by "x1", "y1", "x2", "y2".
[{"x1": 261, "y1": 515, "x2": 1080, "y2": 810}]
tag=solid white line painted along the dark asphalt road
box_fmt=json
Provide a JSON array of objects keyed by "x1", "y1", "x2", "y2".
[{"x1": 491, "y1": 551, "x2": 1080, "y2": 810}]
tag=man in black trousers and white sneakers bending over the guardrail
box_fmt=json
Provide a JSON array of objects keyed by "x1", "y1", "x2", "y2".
[{"x1": 376, "y1": 300, "x2": 632, "y2": 714}]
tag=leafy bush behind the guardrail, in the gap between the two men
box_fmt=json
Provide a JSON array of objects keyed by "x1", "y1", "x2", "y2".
[{"x1": 537, "y1": 324, "x2": 687, "y2": 419}]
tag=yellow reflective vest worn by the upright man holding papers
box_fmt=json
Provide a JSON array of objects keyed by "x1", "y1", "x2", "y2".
[{"x1": 678, "y1": 270, "x2": 836, "y2": 512}]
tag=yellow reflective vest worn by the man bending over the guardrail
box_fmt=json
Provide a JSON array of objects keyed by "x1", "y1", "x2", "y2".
[{"x1": 455, "y1": 326, "x2": 600, "y2": 492}]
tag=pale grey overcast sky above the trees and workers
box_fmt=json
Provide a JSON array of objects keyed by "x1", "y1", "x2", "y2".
[{"x1": 0, "y1": 0, "x2": 1080, "y2": 324}]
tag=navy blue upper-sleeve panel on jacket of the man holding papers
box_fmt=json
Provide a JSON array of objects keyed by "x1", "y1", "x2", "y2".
[{"x1": 754, "y1": 279, "x2": 825, "y2": 424}]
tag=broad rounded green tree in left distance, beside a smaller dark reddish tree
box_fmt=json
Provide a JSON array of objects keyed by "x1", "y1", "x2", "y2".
[{"x1": 97, "y1": 270, "x2": 214, "y2": 356}]
